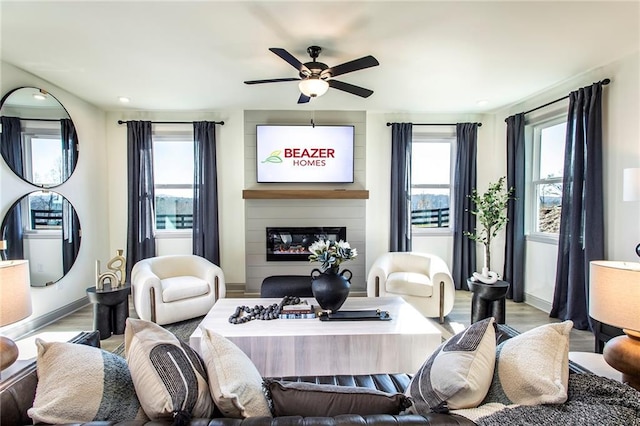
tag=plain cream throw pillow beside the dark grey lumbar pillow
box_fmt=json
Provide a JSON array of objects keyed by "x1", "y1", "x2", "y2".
[{"x1": 200, "y1": 327, "x2": 271, "y2": 418}]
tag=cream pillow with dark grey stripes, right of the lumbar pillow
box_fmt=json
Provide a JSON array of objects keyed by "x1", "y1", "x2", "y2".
[{"x1": 406, "y1": 317, "x2": 496, "y2": 414}]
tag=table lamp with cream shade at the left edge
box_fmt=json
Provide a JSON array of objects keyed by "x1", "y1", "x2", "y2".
[{"x1": 0, "y1": 260, "x2": 31, "y2": 371}]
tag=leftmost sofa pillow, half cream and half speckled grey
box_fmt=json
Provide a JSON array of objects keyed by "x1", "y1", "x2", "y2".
[{"x1": 27, "y1": 339, "x2": 147, "y2": 424}]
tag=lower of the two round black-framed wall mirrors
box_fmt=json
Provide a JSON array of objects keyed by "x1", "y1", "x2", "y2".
[{"x1": 0, "y1": 191, "x2": 80, "y2": 287}]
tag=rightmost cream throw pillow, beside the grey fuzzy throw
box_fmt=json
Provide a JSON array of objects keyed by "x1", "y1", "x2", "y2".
[{"x1": 484, "y1": 321, "x2": 573, "y2": 405}]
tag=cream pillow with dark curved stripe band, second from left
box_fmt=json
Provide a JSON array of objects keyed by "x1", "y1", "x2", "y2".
[{"x1": 124, "y1": 318, "x2": 215, "y2": 420}]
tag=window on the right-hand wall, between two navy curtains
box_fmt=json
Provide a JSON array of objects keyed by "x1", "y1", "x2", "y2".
[{"x1": 529, "y1": 117, "x2": 567, "y2": 236}]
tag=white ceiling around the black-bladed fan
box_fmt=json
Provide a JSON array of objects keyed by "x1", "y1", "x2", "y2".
[{"x1": 0, "y1": 0, "x2": 640, "y2": 113}]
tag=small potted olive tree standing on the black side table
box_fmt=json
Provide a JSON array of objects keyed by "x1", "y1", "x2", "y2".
[{"x1": 464, "y1": 176, "x2": 514, "y2": 283}]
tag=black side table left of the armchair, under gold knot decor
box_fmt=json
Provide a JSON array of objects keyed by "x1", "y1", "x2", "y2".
[{"x1": 87, "y1": 285, "x2": 131, "y2": 340}]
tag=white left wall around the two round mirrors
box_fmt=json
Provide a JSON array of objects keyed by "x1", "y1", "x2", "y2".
[{"x1": 0, "y1": 62, "x2": 111, "y2": 336}]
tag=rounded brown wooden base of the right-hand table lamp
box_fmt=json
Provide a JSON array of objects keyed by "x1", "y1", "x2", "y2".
[{"x1": 602, "y1": 330, "x2": 640, "y2": 391}]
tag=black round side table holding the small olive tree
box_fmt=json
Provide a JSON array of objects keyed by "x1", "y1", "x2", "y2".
[{"x1": 467, "y1": 279, "x2": 509, "y2": 324}]
